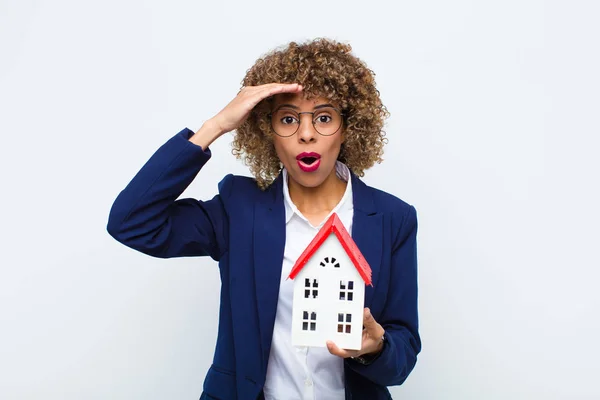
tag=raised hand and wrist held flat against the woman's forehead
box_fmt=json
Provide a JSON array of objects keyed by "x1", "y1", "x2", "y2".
[{"x1": 190, "y1": 83, "x2": 302, "y2": 148}]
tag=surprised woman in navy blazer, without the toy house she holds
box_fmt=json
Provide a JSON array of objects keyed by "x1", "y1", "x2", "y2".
[{"x1": 108, "y1": 39, "x2": 421, "y2": 400}]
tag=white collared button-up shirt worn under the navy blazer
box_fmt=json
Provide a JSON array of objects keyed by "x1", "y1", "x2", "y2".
[{"x1": 264, "y1": 161, "x2": 354, "y2": 400}]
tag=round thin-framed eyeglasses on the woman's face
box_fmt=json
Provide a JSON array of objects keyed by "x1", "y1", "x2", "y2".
[{"x1": 268, "y1": 106, "x2": 344, "y2": 137}]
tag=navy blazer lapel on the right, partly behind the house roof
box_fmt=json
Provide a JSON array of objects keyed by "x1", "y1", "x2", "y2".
[{"x1": 352, "y1": 174, "x2": 383, "y2": 307}]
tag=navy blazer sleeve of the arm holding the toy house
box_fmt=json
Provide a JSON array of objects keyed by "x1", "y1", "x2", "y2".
[{"x1": 348, "y1": 206, "x2": 421, "y2": 386}]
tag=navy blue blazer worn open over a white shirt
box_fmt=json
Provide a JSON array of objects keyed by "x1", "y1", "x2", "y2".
[{"x1": 107, "y1": 129, "x2": 421, "y2": 400}]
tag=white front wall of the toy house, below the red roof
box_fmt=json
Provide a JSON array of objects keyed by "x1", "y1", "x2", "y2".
[{"x1": 292, "y1": 234, "x2": 365, "y2": 349}]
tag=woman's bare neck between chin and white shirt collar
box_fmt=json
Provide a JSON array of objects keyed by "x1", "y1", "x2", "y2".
[{"x1": 288, "y1": 168, "x2": 347, "y2": 215}]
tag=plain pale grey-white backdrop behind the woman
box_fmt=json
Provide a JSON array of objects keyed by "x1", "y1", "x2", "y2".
[{"x1": 0, "y1": 0, "x2": 600, "y2": 400}]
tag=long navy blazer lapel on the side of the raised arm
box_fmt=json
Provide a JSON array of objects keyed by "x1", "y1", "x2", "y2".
[{"x1": 253, "y1": 174, "x2": 285, "y2": 367}]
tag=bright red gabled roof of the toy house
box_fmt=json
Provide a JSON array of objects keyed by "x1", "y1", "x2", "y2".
[{"x1": 288, "y1": 213, "x2": 373, "y2": 286}]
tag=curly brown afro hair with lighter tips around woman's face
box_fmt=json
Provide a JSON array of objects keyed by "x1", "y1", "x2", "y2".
[{"x1": 232, "y1": 39, "x2": 389, "y2": 190}]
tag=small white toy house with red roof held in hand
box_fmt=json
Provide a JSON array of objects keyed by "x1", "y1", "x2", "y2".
[{"x1": 289, "y1": 213, "x2": 371, "y2": 350}]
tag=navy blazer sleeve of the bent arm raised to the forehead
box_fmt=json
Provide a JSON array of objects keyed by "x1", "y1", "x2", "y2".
[{"x1": 107, "y1": 128, "x2": 233, "y2": 260}]
